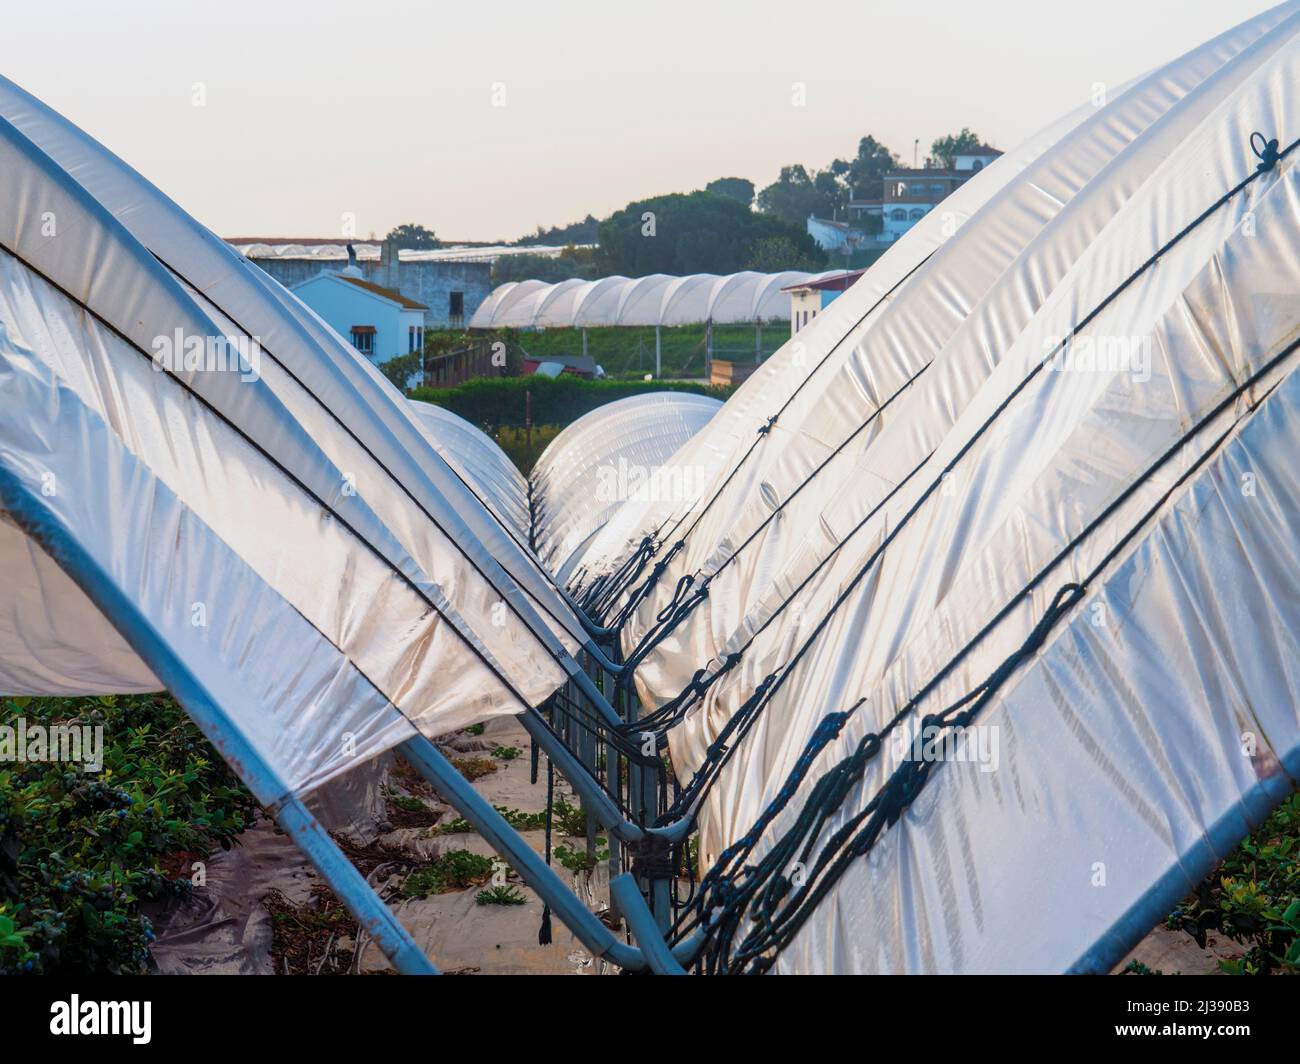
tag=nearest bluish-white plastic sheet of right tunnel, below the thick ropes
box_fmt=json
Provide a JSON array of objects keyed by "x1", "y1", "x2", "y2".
[{"x1": 775, "y1": 364, "x2": 1300, "y2": 974}]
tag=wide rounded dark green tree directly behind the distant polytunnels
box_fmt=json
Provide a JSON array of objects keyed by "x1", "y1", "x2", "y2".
[{"x1": 595, "y1": 191, "x2": 820, "y2": 277}]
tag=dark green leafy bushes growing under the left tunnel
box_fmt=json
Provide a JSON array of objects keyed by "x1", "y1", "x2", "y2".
[{"x1": 0, "y1": 695, "x2": 257, "y2": 974}]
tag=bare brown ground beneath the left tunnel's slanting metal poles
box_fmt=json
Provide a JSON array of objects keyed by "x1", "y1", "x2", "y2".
[{"x1": 144, "y1": 717, "x2": 608, "y2": 976}]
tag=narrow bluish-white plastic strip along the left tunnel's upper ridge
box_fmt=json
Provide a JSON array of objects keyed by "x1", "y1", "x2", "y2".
[{"x1": 0, "y1": 70, "x2": 585, "y2": 656}]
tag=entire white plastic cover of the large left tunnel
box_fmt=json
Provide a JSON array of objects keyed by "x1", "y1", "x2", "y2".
[{"x1": 0, "y1": 82, "x2": 582, "y2": 801}]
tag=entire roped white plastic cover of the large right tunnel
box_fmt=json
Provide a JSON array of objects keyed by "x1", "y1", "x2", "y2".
[{"x1": 600, "y1": 4, "x2": 1300, "y2": 972}]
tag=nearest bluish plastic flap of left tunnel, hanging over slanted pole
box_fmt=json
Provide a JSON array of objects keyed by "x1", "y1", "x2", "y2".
[{"x1": 0, "y1": 325, "x2": 415, "y2": 803}]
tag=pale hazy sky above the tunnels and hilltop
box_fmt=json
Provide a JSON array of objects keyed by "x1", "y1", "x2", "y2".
[{"x1": 0, "y1": 0, "x2": 1271, "y2": 239}]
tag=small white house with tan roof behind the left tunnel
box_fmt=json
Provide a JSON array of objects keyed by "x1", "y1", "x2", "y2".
[{"x1": 293, "y1": 267, "x2": 428, "y2": 364}]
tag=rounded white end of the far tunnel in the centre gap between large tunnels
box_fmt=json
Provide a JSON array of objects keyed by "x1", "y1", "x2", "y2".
[{"x1": 530, "y1": 392, "x2": 722, "y2": 579}]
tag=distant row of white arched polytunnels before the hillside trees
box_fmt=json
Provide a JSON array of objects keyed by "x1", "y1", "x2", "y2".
[{"x1": 469, "y1": 271, "x2": 839, "y2": 329}]
